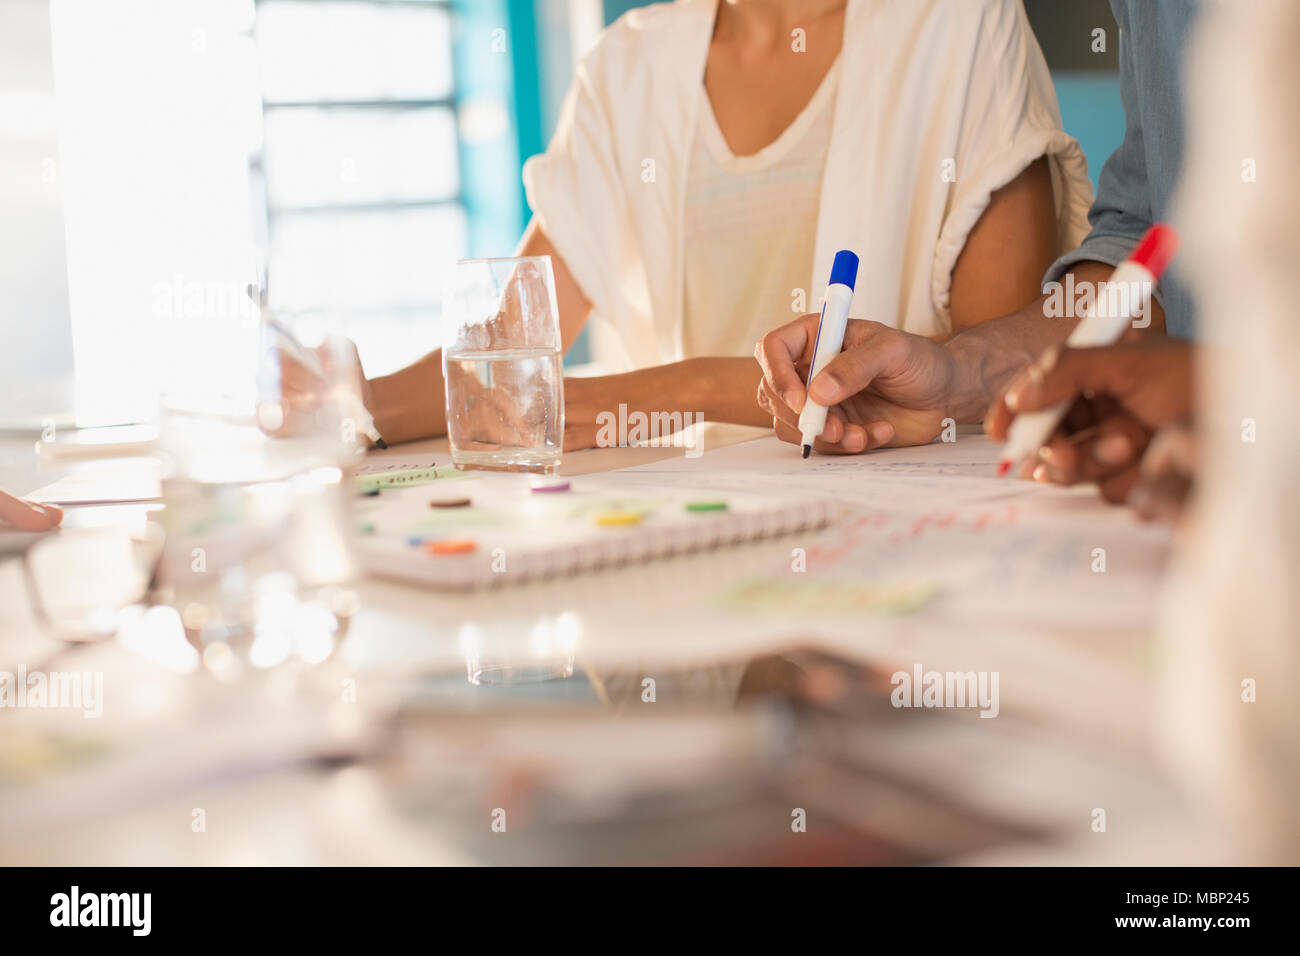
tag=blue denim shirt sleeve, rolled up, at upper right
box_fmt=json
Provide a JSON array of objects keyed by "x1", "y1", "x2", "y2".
[{"x1": 1043, "y1": 0, "x2": 1201, "y2": 338}]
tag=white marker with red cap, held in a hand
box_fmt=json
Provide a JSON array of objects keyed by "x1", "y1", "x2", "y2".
[{"x1": 997, "y1": 224, "x2": 1178, "y2": 475}]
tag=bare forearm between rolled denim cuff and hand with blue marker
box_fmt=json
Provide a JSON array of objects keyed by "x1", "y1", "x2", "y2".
[{"x1": 944, "y1": 263, "x2": 1113, "y2": 423}]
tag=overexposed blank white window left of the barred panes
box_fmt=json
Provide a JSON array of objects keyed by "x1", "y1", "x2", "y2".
[{"x1": 49, "y1": 0, "x2": 260, "y2": 425}]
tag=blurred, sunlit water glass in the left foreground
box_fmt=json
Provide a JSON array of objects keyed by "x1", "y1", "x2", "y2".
[{"x1": 157, "y1": 282, "x2": 361, "y2": 676}]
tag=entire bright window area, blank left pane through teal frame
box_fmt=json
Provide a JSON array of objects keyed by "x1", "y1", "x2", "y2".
[{"x1": 35, "y1": 0, "x2": 576, "y2": 425}]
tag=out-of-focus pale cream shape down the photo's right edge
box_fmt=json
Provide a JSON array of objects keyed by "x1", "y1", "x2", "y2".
[{"x1": 1162, "y1": 0, "x2": 1300, "y2": 864}]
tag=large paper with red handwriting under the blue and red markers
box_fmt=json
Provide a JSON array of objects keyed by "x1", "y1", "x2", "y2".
[{"x1": 620, "y1": 436, "x2": 1169, "y2": 630}]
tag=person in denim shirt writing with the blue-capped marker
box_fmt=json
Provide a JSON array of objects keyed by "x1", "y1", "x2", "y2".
[{"x1": 755, "y1": 0, "x2": 1200, "y2": 463}]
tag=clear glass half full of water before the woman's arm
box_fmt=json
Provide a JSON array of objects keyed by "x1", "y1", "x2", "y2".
[{"x1": 442, "y1": 256, "x2": 564, "y2": 473}]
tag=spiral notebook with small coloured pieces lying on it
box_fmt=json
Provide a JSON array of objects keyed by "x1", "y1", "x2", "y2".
[{"x1": 356, "y1": 475, "x2": 841, "y2": 589}]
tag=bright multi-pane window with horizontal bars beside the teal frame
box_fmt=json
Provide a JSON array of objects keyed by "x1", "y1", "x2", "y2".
[{"x1": 254, "y1": 0, "x2": 467, "y2": 375}]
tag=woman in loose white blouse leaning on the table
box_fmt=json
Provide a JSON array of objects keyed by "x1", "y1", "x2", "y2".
[{"x1": 367, "y1": 0, "x2": 1092, "y2": 450}]
